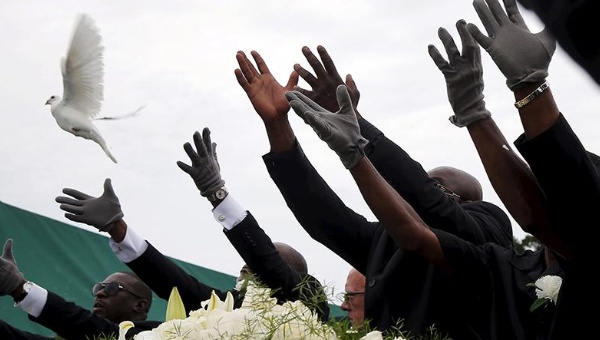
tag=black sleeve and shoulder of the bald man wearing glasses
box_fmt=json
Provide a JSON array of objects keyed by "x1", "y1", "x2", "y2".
[{"x1": 359, "y1": 118, "x2": 513, "y2": 246}]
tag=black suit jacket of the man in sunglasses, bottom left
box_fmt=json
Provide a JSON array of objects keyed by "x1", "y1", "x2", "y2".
[{"x1": 29, "y1": 291, "x2": 160, "y2": 340}]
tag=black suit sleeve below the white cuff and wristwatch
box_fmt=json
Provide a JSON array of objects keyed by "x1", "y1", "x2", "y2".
[{"x1": 225, "y1": 212, "x2": 329, "y2": 321}]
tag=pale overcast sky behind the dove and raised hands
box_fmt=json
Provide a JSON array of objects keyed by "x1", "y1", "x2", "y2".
[{"x1": 0, "y1": 0, "x2": 600, "y2": 302}]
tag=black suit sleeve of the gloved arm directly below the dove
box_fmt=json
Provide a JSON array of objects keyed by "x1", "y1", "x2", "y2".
[{"x1": 126, "y1": 243, "x2": 241, "y2": 313}]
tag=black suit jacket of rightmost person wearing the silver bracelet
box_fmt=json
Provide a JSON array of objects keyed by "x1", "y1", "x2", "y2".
[{"x1": 515, "y1": 114, "x2": 600, "y2": 339}]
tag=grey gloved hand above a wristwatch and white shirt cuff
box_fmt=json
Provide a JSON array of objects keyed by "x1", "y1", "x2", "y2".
[{"x1": 177, "y1": 128, "x2": 225, "y2": 197}]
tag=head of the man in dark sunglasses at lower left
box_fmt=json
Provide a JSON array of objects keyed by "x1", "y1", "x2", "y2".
[{"x1": 92, "y1": 273, "x2": 140, "y2": 323}]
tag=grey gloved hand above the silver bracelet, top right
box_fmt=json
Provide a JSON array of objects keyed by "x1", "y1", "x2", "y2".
[{"x1": 467, "y1": 0, "x2": 556, "y2": 91}]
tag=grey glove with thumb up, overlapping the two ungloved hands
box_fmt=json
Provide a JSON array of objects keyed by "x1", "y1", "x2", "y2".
[{"x1": 285, "y1": 85, "x2": 367, "y2": 169}]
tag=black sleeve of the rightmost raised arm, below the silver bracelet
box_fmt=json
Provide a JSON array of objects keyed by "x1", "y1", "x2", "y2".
[{"x1": 515, "y1": 114, "x2": 600, "y2": 255}]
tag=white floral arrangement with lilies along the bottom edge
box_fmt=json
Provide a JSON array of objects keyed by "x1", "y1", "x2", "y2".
[{"x1": 119, "y1": 285, "x2": 405, "y2": 340}]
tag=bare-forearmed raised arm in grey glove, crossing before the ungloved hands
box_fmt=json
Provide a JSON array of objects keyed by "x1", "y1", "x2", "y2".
[{"x1": 286, "y1": 85, "x2": 447, "y2": 269}]
